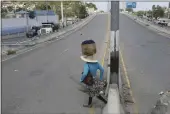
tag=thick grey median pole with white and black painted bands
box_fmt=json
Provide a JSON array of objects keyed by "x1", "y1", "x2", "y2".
[{"x1": 110, "y1": 1, "x2": 119, "y2": 86}]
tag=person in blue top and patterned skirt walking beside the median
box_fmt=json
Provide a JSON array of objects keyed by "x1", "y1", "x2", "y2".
[{"x1": 80, "y1": 40, "x2": 107, "y2": 107}]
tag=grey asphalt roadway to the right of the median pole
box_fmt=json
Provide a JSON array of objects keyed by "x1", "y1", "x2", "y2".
[{"x1": 119, "y1": 14, "x2": 170, "y2": 113}]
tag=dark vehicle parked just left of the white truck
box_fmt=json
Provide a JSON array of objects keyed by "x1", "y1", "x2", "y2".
[{"x1": 26, "y1": 26, "x2": 41, "y2": 38}]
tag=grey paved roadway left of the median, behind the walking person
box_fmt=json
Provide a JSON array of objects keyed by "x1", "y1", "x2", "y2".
[{"x1": 2, "y1": 14, "x2": 107, "y2": 114}]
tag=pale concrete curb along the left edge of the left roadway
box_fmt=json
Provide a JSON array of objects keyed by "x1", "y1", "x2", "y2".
[{"x1": 1, "y1": 14, "x2": 96, "y2": 62}]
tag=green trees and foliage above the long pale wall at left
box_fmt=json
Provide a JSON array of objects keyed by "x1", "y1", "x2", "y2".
[{"x1": 2, "y1": 0, "x2": 89, "y2": 19}]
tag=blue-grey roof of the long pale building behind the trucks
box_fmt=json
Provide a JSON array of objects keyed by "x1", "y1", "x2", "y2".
[{"x1": 34, "y1": 10, "x2": 56, "y2": 16}]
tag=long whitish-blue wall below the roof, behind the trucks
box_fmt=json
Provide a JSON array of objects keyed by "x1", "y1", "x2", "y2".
[{"x1": 1, "y1": 15, "x2": 59, "y2": 35}]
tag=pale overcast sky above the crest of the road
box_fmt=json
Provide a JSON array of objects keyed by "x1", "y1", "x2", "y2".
[{"x1": 93, "y1": 2, "x2": 168, "y2": 11}]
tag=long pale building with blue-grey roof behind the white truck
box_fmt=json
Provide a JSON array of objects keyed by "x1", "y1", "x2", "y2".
[{"x1": 1, "y1": 10, "x2": 59, "y2": 35}]
